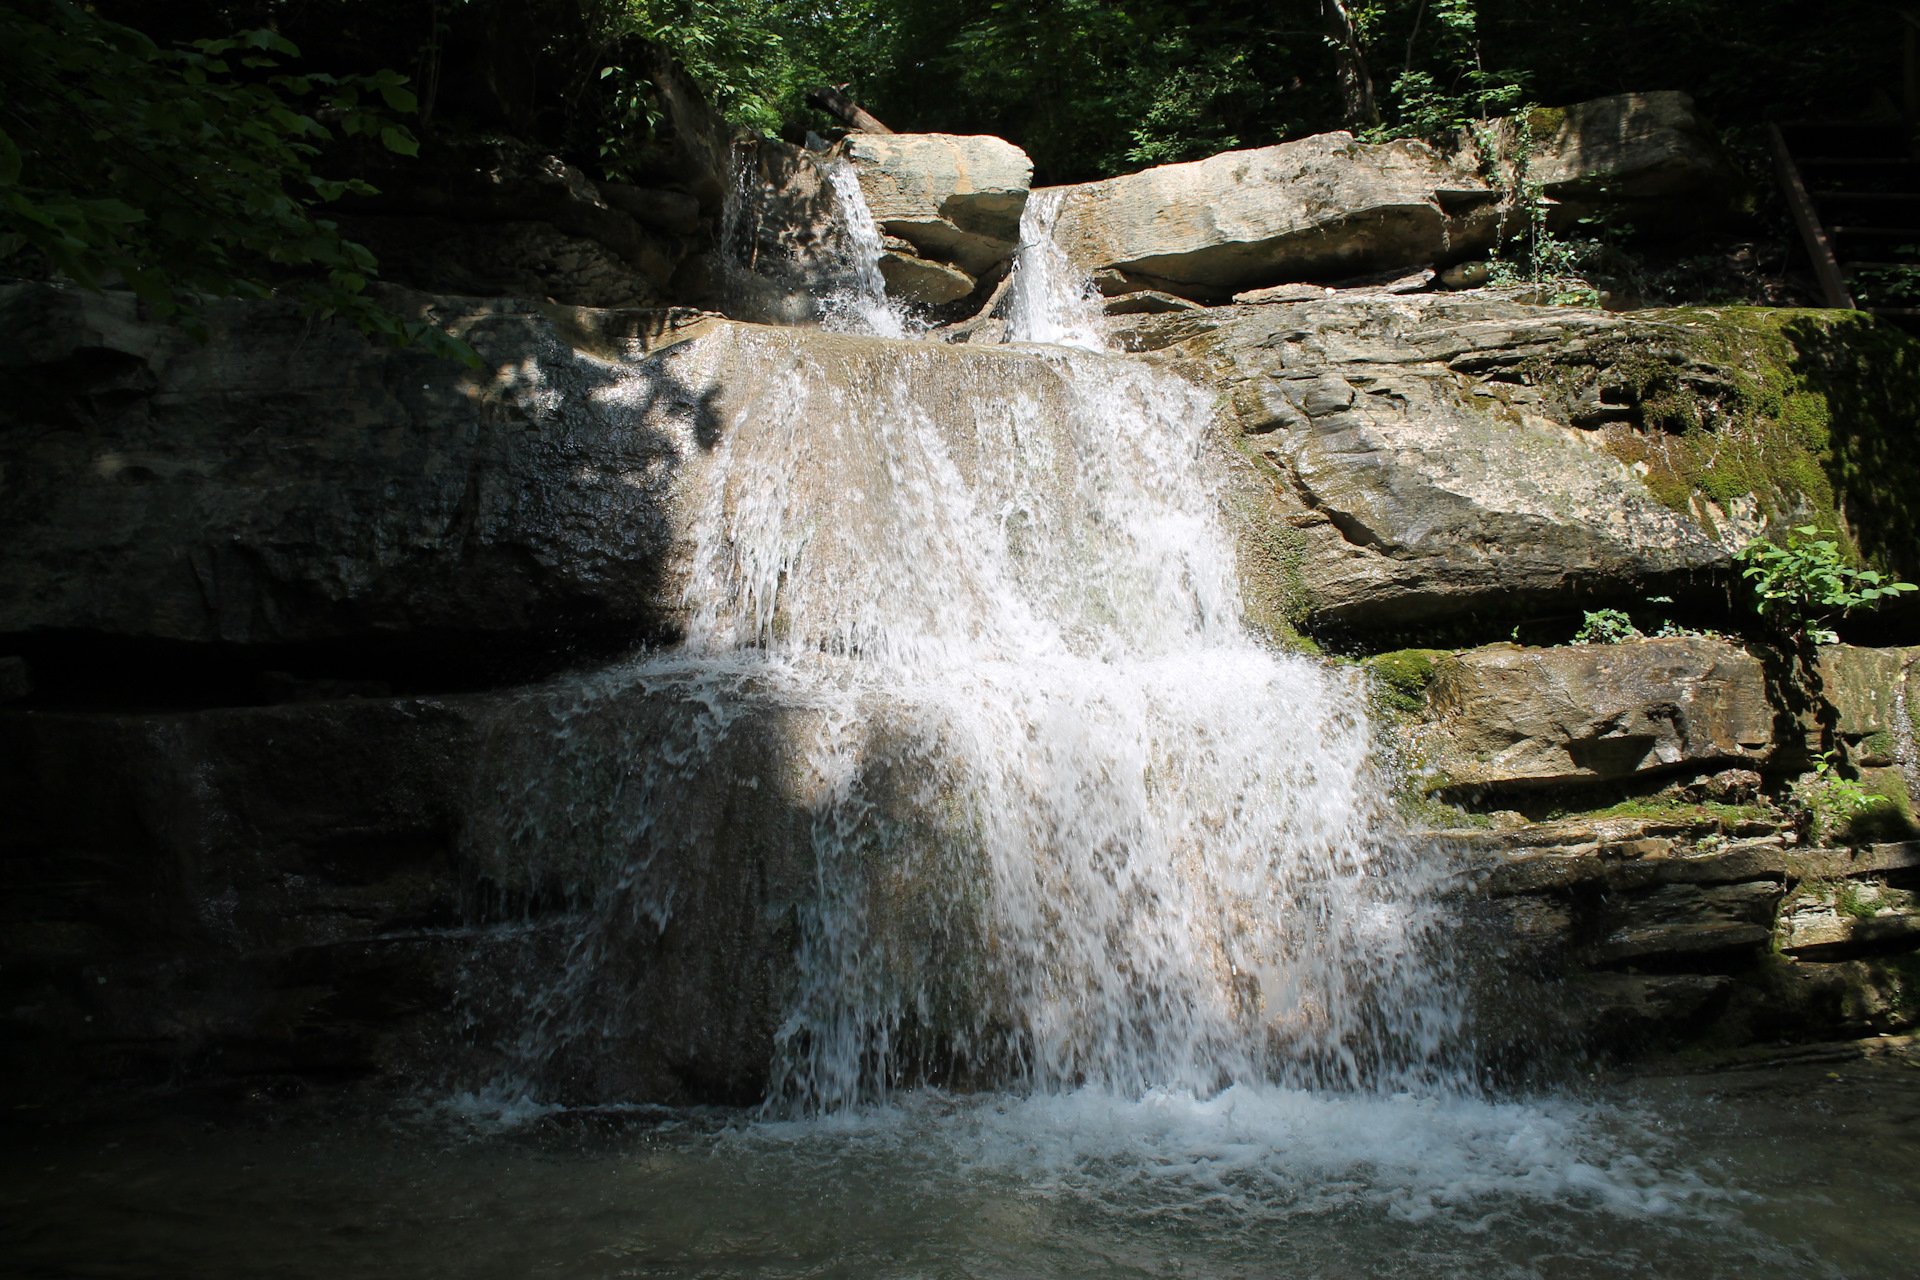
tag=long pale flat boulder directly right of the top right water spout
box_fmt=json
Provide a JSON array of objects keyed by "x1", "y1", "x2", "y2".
[{"x1": 1054, "y1": 132, "x2": 1494, "y2": 301}]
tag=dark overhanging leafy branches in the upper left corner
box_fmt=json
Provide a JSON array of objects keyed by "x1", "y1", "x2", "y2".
[{"x1": 0, "y1": 0, "x2": 470, "y2": 357}]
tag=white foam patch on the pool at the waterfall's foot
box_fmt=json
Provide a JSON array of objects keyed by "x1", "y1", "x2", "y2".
[{"x1": 720, "y1": 1084, "x2": 1741, "y2": 1232}]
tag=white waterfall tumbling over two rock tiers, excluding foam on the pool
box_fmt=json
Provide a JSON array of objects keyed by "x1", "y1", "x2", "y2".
[{"x1": 474, "y1": 171, "x2": 1463, "y2": 1111}]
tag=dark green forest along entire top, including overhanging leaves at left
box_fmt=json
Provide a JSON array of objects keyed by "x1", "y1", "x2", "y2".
[{"x1": 0, "y1": 0, "x2": 1901, "y2": 339}]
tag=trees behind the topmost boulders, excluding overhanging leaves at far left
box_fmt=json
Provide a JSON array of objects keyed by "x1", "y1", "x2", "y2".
[{"x1": 78, "y1": 0, "x2": 1899, "y2": 182}]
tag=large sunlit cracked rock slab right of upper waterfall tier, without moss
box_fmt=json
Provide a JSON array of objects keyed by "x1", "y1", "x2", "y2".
[{"x1": 1159, "y1": 294, "x2": 1732, "y2": 628}]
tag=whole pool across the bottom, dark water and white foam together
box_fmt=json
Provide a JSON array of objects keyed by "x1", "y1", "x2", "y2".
[{"x1": 0, "y1": 1059, "x2": 1920, "y2": 1280}]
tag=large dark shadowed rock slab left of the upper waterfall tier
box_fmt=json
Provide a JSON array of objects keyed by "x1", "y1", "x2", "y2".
[{"x1": 0, "y1": 286, "x2": 720, "y2": 704}]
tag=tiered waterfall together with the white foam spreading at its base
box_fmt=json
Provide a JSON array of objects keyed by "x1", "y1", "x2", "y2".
[{"x1": 445, "y1": 175, "x2": 1713, "y2": 1221}]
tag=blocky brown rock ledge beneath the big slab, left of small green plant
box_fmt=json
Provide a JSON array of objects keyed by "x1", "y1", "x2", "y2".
[{"x1": 1427, "y1": 637, "x2": 1772, "y2": 789}]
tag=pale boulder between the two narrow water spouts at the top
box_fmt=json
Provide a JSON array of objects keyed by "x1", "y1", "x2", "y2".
[{"x1": 841, "y1": 132, "x2": 1033, "y2": 276}]
